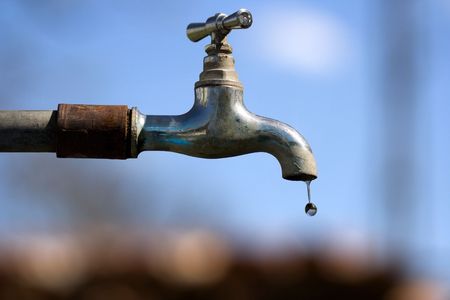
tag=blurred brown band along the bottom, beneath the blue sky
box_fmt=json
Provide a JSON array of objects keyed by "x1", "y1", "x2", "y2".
[{"x1": 0, "y1": 231, "x2": 441, "y2": 300}]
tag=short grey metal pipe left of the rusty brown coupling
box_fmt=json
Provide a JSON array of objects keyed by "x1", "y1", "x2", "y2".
[{"x1": 0, "y1": 110, "x2": 57, "y2": 152}]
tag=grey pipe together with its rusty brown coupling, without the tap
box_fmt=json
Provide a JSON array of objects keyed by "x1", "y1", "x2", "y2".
[{"x1": 0, "y1": 104, "x2": 136, "y2": 159}]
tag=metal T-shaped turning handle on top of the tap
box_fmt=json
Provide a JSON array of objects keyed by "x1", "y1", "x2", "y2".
[{"x1": 186, "y1": 8, "x2": 253, "y2": 44}]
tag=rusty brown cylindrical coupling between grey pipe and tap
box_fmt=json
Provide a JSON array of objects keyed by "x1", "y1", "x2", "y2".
[{"x1": 56, "y1": 104, "x2": 130, "y2": 159}]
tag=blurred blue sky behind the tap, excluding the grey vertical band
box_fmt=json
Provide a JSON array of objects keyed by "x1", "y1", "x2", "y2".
[{"x1": 0, "y1": 0, "x2": 450, "y2": 288}]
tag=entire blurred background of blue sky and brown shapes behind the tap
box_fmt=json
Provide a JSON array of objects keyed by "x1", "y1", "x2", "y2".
[{"x1": 0, "y1": 0, "x2": 450, "y2": 299}]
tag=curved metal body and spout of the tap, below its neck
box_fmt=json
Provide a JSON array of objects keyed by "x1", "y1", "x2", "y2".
[{"x1": 137, "y1": 85, "x2": 317, "y2": 181}]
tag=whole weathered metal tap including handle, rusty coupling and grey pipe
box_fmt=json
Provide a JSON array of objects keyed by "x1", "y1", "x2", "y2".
[{"x1": 0, "y1": 9, "x2": 317, "y2": 181}]
